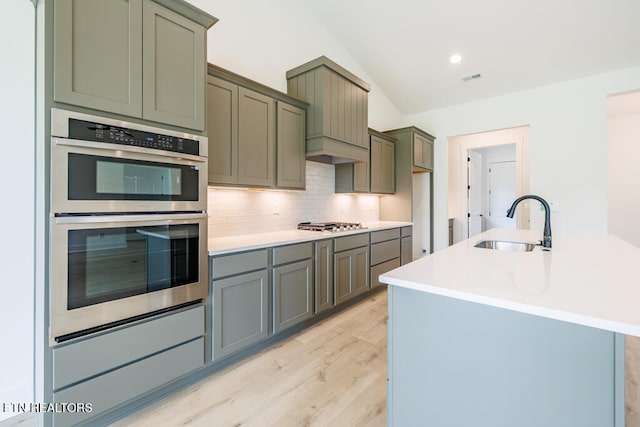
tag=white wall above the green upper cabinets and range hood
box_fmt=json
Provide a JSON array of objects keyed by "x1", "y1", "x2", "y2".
[{"x1": 189, "y1": 0, "x2": 401, "y2": 131}]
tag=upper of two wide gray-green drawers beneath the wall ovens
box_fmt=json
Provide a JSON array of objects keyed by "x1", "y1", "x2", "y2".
[{"x1": 53, "y1": 306, "x2": 204, "y2": 390}]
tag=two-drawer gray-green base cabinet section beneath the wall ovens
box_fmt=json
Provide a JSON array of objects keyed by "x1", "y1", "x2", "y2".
[{"x1": 52, "y1": 305, "x2": 204, "y2": 426}]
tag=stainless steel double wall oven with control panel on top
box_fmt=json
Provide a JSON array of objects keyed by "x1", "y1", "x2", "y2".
[{"x1": 49, "y1": 109, "x2": 208, "y2": 345}]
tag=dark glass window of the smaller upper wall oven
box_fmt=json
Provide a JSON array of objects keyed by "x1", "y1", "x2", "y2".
[{"x1": 68, "y1": 153, "x2": 200, "y2": 201}]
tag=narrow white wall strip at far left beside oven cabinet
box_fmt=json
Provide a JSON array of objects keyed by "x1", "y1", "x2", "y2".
[{"x1": 0, "y1": 0, "x2": 35, "y2": 420}]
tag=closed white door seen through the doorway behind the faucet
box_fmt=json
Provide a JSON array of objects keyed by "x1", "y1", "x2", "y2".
[{"x1": 486, "y1": 162, "x2": 516, "y2": 229}]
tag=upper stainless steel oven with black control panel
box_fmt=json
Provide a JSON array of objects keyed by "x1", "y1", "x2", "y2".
[{"x1": 51, "y1": 109, "x2": 207, "y2": 213}]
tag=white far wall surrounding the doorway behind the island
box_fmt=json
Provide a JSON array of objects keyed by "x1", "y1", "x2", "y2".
[{"x1": 403, "y1": 67, "x2": 640, "y2": 249}]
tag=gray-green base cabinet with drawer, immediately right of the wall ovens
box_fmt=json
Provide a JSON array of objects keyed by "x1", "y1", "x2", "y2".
[{"x1": 211, "y1": 249, "x2": 269, "y2": 362}]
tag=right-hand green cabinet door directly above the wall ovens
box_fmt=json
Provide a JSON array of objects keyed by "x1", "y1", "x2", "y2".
[{"x1": 142, "y1": 0, "x2": 207, "y2": 131}]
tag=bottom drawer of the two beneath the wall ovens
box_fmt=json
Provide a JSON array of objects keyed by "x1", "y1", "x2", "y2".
[{"x1": 53, "y1": 338, "x2": 204, "y2": 426}]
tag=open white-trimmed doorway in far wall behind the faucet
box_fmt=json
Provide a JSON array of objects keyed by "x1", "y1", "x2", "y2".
[{"x1": 448, "y1": 126, "x2": 529, "y2": 243}]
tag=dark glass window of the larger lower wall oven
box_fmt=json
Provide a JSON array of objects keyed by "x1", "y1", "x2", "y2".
[{"x1": 67, "y1": 224, "x2": 200, "y2": 310}]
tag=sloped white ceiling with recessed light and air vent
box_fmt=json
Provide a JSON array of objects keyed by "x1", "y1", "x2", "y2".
[{"x1": 301, "y1": 0, "x2": 640, "y2": 114}]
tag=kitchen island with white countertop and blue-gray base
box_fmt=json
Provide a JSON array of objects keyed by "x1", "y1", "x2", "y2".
[{"x1": 380, "y1": 229, "x2": 640, "y2": 427}]
